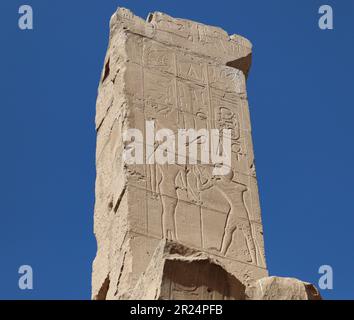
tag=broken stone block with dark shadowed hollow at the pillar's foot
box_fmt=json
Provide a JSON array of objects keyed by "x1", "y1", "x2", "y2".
[{"x1": 130, "y1": 241, "x2": 245, "y2": 300}]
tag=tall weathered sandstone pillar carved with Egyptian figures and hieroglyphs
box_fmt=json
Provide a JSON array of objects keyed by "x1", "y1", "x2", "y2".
[{"x1": 92, "y1": 8, "x2": 268, "y2": 299}]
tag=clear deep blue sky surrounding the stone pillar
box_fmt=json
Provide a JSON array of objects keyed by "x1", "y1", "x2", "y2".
[{"x1": 0, "y1": 0, "x2": 354, "y2": 299}]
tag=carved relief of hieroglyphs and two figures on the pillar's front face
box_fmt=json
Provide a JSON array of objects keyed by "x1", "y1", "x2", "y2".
[{"x1": 121, "y1": 34, "x2": 264, "y2": 266}]
